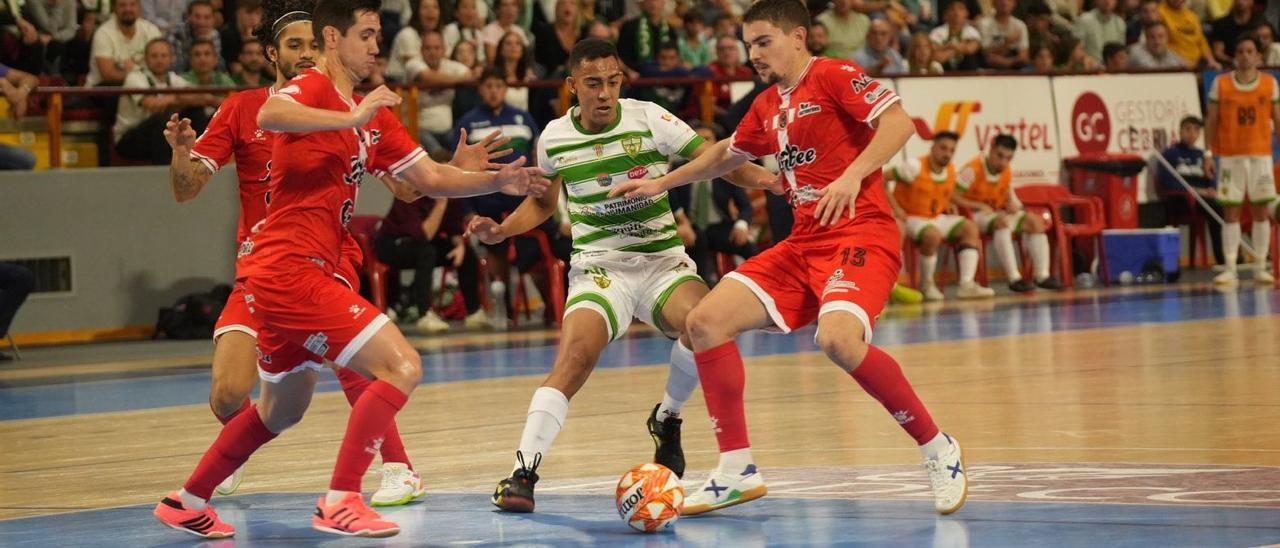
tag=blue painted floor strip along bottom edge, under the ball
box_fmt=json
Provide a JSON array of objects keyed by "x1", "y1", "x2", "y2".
[{"x1": 0, "y1": 493, "x2": 1280, "y2": 548}]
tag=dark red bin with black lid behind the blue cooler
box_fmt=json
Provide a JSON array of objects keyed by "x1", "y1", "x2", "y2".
[{"x1": 1062, "y1": 154, "x2": 1147, "y2": 228}]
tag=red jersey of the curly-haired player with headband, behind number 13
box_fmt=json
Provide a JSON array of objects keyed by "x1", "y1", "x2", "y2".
[{"x1": 191, "y1": 87, "x2": 271, "y2": 243}]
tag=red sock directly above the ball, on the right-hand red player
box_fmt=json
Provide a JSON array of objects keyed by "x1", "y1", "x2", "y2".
[{"x1": 694, "y1": 341, "x2": 751, "y2": 453}]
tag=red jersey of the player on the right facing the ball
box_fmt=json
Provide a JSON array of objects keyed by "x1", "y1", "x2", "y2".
[{"x1": 731, "y1": 58, "x2": 901, "y2": 232}]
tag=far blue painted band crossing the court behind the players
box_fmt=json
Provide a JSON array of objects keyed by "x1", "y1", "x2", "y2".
[{"x1": 0, "y1": 288, "x2": 1280, "y2": 421}]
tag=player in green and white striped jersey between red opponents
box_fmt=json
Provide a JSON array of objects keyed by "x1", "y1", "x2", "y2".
[{"x1": 470, "y1": 38, "x2": 776, "y2": 512}]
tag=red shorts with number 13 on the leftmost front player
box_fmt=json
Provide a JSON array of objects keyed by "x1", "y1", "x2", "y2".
[{"x1": 238, "y1": 266, "x2": 390, "y2": 383}]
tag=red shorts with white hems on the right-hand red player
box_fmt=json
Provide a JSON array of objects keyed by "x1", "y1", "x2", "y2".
[{"x1": 724, "y1": 220, "x2": 902, "y2": 342}]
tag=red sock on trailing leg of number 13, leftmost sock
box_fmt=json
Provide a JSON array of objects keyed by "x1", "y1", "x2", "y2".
[{"x1": 183, "y1": 406, "x2": 275, "y2": 501}]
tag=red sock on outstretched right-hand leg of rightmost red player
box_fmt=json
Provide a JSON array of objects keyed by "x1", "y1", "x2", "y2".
[{"x1": 852, "y1": 346, "x2": 938, "y2": 446}]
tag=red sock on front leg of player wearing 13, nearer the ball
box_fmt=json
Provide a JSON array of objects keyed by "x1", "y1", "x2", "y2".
[{"x1": 329, "y1": 380, "x2": 408, "y2": 493}]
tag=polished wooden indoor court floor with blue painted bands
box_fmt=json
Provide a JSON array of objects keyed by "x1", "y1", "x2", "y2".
[{"x1": 0, "y1": 284, "x2": 1280, "y2": 547}]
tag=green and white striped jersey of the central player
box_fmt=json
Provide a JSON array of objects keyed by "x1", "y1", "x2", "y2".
[{"x1": 538, "y1": 99, "x2": 703, "y2": 270}]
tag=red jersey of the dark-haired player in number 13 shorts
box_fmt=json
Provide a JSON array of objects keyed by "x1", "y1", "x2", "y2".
[{"x1": 239, "y1": 69, "x2": 426, "y2": 278}]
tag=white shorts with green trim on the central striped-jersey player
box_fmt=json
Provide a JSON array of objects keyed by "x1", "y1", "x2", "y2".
[{"x1": 564, "y1": 254, "x2": 703, "y2": 341}]
